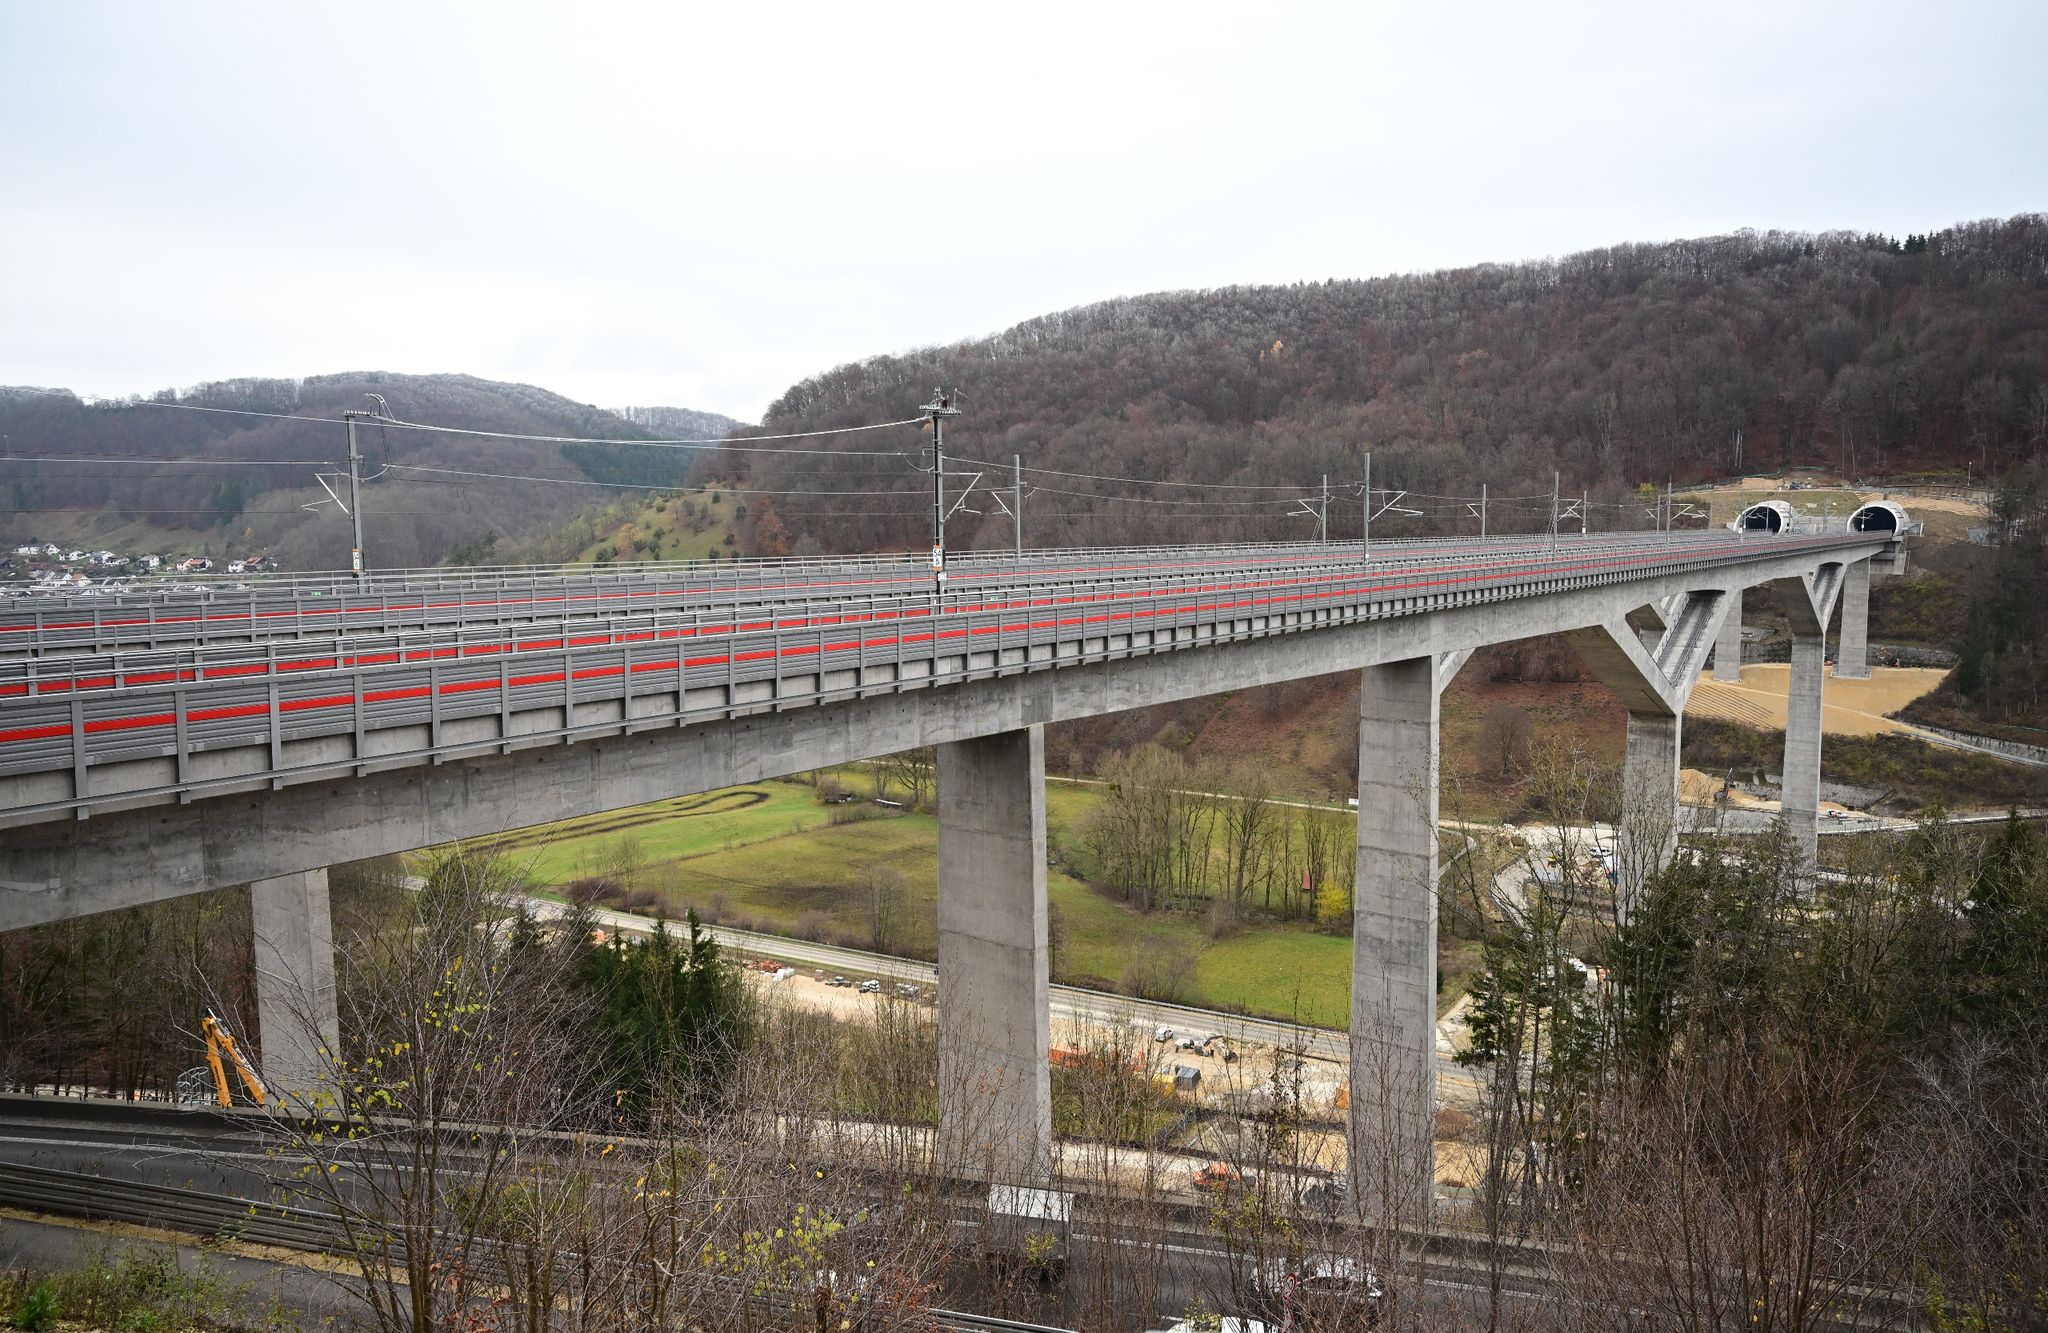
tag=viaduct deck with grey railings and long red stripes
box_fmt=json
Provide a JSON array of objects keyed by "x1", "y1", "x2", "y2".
[{"x1": 0, "y1": 532, "x2": 1874, "y2": 823}]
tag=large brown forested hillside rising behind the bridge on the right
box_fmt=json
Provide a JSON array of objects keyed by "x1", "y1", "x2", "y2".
[{"x1": 725, "y1": 215, "x2": 2048, "y2": 551}]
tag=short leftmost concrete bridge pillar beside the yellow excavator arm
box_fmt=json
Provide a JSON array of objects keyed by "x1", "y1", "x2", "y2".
[{"x1": 250, "y1": 870, "x2": 340, "y2": 1095}]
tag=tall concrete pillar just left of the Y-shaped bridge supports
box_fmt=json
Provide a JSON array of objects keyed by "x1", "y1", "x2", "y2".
[{"x1": 1350, "y1": 657, "x2": 1438, "y2": 1224}]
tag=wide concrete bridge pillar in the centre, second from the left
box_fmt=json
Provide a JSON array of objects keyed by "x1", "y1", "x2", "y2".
[{"x1": 938, "y1": 727, "x2": 1053, "y2": 1184}]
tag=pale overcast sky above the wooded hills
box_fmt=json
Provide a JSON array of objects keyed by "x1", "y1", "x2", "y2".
[{"x1": 0, "y1": 0, "x2": 2048, "y2": 420}]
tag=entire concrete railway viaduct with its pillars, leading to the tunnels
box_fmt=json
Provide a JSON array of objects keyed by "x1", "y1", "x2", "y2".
[{"x1": 0, "y1": 512, "x2": 1903, "y2": 1218}]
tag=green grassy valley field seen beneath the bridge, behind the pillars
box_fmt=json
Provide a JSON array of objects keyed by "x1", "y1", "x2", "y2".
[{"x1": 452, "y1": 770, "x2": 1456, "y2": 1026}]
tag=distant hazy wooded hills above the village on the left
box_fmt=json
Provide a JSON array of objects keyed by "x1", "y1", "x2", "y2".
[{"x1": 0, "y1": 373, "x2": 737, "y2": 569}]
